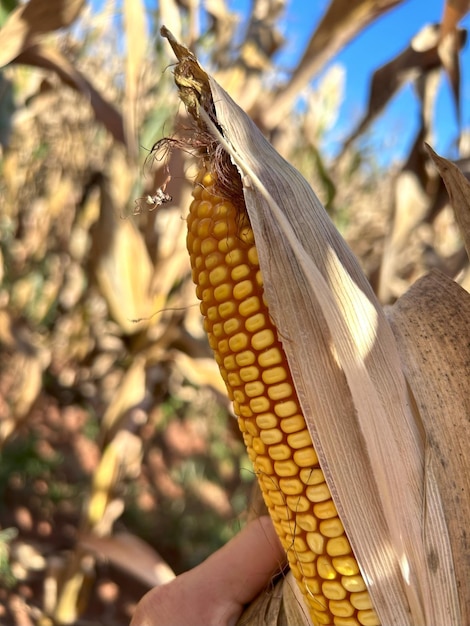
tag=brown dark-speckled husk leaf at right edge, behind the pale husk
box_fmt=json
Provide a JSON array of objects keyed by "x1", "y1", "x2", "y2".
[{"x1": 390, "y1": 271, "x2": 470, "y2": 624}]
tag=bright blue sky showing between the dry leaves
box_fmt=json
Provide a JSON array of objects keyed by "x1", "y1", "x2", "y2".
[{"x1": 230, "y1": 0, "x2": 470, "y2": 164}]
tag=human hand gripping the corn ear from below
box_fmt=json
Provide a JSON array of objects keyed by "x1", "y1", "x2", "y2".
[{"x1": 130, "y1": 516, "x2": 285, "y2": 626}]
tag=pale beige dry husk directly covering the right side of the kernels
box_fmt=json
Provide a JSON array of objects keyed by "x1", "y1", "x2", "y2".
[{"x1": 162, "y1": 29, "x2": 459, "y2": 626}]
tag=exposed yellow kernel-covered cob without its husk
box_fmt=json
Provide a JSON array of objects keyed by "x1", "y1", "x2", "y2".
[{"x1": 187, "y1": 169, "x2": 379, "y2": 626}]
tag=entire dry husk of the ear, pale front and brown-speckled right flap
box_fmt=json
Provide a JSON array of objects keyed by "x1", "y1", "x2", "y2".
[{"x1": 164, "y1": 31, "x2": 470, "y2": 626}]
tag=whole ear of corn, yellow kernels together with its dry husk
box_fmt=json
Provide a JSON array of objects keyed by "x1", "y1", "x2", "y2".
[{"x1": 162, "y1": 27, "x2": 470, "y2": 626}]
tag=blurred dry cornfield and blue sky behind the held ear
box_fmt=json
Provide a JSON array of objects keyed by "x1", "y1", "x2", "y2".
[{"x1": 0, "y1": 0, "x2": 470, "y2": 626}]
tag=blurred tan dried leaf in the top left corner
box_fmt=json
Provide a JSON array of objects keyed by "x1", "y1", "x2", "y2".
[{"x1": 0, "y1": 0, "x2": 85, "y2": 67}]
